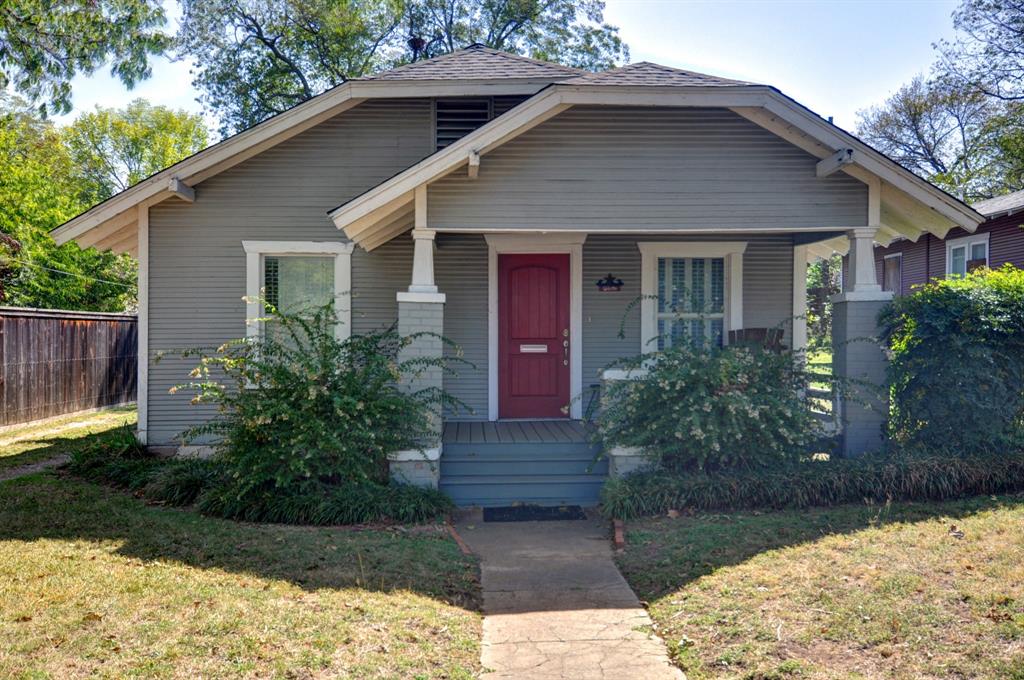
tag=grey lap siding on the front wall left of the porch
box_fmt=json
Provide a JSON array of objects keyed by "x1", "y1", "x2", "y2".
[{"x1": 148, "y1": 99, "x2": 432, "y2": 443}]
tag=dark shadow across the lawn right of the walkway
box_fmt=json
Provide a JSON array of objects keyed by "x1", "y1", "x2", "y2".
[{"x1": 616, "y1": 494, "x2": 1024, "y2": 600}]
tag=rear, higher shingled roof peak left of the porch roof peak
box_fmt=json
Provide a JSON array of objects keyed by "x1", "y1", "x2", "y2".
[{"x1": 359, "y1": 44, "x2": 583, "y2": 81}]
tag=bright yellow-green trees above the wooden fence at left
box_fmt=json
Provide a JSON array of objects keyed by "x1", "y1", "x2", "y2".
[{"x1": 0, "y1": 96, "x2": 207, "y2": 311}]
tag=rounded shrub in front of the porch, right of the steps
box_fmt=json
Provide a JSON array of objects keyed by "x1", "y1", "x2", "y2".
[{"x1": 597, "y1": 342, "x2": 822, "y2": 472}]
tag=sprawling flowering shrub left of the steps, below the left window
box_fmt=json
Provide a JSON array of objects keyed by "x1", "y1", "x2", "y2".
[{"x1": 176, "y1": 305, "x2": 460, "y2": 522}]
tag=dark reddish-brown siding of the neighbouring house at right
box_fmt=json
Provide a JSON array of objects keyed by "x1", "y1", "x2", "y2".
[{"x1": 874, "y1": 215, "x2": 1024, "y2": 295}]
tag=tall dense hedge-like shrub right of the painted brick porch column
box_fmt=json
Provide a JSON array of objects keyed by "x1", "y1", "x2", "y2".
[{"x1": 880, "y1": 265, "x2": 1024, "y2": 453}]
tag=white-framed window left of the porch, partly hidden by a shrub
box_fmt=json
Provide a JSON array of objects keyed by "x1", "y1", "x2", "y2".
[{"x1": 242, "y1": 241, "x2": 352, "y2": 338}]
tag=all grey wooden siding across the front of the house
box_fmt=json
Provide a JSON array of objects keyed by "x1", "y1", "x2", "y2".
[{"x1": 148, "y1": 99, "x2": 831, "y2": 444}]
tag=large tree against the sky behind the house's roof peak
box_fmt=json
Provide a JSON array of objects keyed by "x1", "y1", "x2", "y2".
[{"x1": 177, "y1": 0, "x2": 629, "y2": 134}]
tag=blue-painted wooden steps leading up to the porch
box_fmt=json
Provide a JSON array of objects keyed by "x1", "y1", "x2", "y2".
[{"x1": 440, "y1": 441, "x2": 608, "y2": 507}]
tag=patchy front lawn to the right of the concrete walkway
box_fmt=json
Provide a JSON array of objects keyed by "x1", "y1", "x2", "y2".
[{"x1": 618, "y1": 497, "x2": 1024, "y2": 680}]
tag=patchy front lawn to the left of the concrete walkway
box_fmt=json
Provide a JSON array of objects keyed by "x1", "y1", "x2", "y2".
[{"x1": 0, "y1": 473, "x2": 480, "y2": 678}]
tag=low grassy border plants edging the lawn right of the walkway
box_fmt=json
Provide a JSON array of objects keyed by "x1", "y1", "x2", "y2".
[{"x1": 601, "y1": 452, "x2": 1024, "y2": 519}]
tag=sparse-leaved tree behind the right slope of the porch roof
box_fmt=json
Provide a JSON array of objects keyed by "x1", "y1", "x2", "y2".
[{"x1": 857, "y1": 76, "x2": 1020, "y2": 201}]
